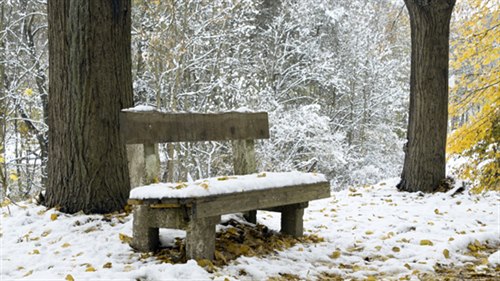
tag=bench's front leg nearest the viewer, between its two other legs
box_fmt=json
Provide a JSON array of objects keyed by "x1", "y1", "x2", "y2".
[{"x1": 186, "y1": 216, "x2": 220, "y2": 260}]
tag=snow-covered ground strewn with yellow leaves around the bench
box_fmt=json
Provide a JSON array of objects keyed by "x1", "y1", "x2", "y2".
[{"x1": 0, "y1": 180, "x2": 500, "y2": 281}]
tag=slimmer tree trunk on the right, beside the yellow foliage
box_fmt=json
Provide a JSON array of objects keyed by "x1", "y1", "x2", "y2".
[{"x1": 398, "y1": 0, "x2": 455, "y2": 192}]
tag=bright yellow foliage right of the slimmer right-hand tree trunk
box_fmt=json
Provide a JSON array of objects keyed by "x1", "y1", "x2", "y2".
[{"x1": 447, "y1": 0, "x2": 500, "y2": 192}]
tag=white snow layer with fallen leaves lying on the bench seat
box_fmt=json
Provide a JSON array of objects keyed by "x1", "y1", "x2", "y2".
[{"x1": 130, "y1": 172, "x2": 326, "y2": 199}]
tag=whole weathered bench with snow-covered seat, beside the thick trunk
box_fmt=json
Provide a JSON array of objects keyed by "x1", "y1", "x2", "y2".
[{"x1": 121, "y1": 111, "x2": 330, "y2": 259}]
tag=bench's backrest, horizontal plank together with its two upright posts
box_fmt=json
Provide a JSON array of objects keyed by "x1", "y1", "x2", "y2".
[{"x1": 120, "y1": 108, "x2": 269, "y2": 183}]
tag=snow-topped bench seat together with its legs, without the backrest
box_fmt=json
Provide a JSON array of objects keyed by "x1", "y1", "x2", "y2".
[{"x1": 129, "y1": 172, "x2": 330, "y2": 259}]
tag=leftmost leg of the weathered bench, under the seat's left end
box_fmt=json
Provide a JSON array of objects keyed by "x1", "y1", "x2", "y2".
[{"x1": 131, "y1": 205, "x2": 159, "y2": 252}]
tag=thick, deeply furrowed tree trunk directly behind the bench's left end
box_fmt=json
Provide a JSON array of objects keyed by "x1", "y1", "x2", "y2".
[{"x1": 46, "y1": 0, "x2": 133, "y2": 213}]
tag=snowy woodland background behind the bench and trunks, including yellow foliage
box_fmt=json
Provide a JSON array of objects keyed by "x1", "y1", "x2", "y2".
[{"x1": 0, "y1": 0, "x2": 500, "y2": 200}]
